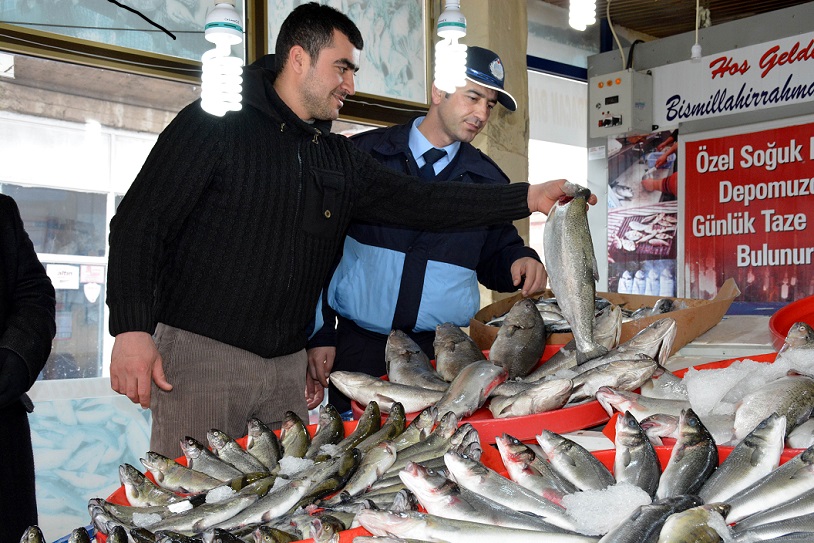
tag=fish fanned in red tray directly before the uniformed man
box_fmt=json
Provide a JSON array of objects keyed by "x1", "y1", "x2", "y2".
[{"x1": 330, "y1": 299, "x2": 676, "y2": 418}]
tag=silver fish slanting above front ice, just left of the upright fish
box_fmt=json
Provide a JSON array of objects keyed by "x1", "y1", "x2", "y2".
[{"x1": 536, "y1": 430, "x2": 614, "y2": 490}]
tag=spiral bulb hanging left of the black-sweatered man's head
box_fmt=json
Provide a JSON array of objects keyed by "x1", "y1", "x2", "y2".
[{"x1": 201, "y1": 0, "x2": 243, "y2": 117}]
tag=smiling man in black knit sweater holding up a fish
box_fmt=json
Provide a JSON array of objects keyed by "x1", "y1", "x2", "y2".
[{"x1": 107, "y1": 2, "x2": 592, "y2": 456}]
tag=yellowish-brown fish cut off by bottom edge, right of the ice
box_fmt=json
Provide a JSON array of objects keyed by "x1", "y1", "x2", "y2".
[{"x1": 658, "y1": 503, "x2": 732, "y2": 543}]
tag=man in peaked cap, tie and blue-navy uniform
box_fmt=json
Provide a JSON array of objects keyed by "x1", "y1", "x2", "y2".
[{"x1": 308, "y1": 47, "x2": 547, "y2": 418}]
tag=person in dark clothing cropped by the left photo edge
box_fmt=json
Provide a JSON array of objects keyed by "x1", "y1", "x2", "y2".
[{"x1": 0, "y1": 194, "x2": 56, "y2": 541}]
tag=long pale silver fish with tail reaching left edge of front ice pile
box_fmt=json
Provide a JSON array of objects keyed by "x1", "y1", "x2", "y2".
[{"x1": 444, "y1": 451, "x2": 575, "y2": 530}]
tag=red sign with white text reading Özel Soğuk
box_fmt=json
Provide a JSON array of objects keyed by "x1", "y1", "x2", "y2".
[{"x1": 681, "y1": 116, "x2": 814, "y2": 313}]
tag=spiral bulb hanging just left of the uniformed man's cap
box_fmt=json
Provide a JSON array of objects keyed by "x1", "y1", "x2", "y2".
[{"x1": 434, "y1": 0, "x2": 466, "y2": 93}]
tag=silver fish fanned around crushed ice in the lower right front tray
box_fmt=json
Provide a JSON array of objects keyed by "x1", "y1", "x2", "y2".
[{"x1": 355, "y1": 410, "x2": 814, "y2": 543}]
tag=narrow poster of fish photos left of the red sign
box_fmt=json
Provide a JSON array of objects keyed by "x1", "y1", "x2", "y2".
[{"x1": 608, "y1": 130, "x2": 679, "y2": 297}]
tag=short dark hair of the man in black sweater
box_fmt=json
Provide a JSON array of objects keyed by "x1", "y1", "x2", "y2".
[{"x1": 274, "y1": 2, "x2": 364, "y2": 73}]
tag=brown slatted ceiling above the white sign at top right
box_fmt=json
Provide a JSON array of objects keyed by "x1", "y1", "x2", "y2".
[{"x1": 539, "y1": 0, "x2": 809, "y2": 38}]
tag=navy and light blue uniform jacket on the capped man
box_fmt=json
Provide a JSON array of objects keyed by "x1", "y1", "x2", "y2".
[{"x1": 308, "y1": 118, "x2": 540, "y2": 347}]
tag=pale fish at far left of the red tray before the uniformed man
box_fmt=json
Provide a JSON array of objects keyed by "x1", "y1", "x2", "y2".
[{"x1": 330, "y1": 371, "x2": 449, "y2": 413}]
